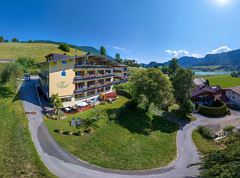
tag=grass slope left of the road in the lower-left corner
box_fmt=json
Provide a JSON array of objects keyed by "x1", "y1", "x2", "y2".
[{"x1": 0, "y1": 96, "x2": 54, "y2": 177}]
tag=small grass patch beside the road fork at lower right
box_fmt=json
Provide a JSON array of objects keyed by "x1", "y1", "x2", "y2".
[{"x1": 192, "y1": 130, "x2": 221, "y2": 154}]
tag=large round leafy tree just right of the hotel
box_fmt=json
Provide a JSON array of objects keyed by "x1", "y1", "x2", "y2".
[{"x1": 130, "y1": 69, "x2": 173, "y2": 111}]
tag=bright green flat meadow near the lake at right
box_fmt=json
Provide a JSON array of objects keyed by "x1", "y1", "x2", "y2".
[{"x1": 203, "y1": 75, "x2": 240, "y2": 88}]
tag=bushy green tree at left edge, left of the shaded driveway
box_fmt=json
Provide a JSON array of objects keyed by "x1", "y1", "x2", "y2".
[{"x1": 0, "y1": 63, "x2": 23, "y2": 93}]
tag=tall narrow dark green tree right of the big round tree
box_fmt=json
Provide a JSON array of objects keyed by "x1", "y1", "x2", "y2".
[{"x1": 172, "y1": 68, "x2": 194, "y2": 115}]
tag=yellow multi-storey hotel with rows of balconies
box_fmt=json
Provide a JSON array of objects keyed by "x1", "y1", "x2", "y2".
[{"x1": 39, "y1": 54, "x2": 128, "y2": 107}]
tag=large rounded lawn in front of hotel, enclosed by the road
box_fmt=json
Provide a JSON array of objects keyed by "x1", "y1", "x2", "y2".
[{"x1": 45, "y1": 97, "x2": 178, "y2": 170}]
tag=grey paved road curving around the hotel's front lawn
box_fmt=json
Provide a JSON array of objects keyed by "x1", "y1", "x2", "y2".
[{"x1": 21, "y1": 80, "x2": 232, "y2": 178}]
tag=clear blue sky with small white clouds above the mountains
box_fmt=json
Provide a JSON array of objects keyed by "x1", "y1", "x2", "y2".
[{"x1": 0, "y1": 0, "x2": 240, "y2": 63}]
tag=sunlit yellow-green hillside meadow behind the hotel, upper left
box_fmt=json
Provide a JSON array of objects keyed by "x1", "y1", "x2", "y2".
[{"x1": 0, "y1": 43, "x2": 83, "y2": 62}]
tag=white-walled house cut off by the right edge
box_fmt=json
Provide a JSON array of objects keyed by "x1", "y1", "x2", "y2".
[{"x1": 224, "y1": 86, "x2": 240, "y2": 106}]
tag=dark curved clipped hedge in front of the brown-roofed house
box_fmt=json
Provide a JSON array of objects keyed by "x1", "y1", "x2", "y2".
[{"x1": 198, "y1": 102, "x2": 228, "y2": 117}]
